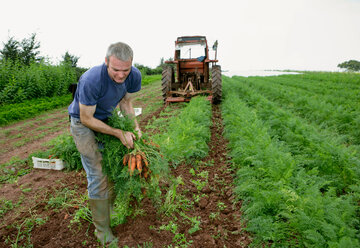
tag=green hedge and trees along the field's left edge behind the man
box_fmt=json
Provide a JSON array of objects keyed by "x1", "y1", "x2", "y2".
[{"x1": 0, "y1": 33, "x2": 164, "y2": 106}]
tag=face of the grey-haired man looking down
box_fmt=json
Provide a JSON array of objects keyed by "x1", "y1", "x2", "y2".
[{"x1": 105, "y1": 56, "x2": 132, "y2": 83}]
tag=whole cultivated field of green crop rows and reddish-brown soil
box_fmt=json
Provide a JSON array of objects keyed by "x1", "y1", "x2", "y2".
[{"x1": 0, "y1": 72, "x2": 360, "y2": 247}]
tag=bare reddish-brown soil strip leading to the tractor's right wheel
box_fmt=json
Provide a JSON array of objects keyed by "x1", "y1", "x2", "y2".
[{"x1": 170, "y1": 105, "x2": 251, "y2": 248}]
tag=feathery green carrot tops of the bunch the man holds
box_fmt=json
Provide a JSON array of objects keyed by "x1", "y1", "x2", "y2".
[{"x1": 97, "y1": 111, "x2": 168, "y2": 225}]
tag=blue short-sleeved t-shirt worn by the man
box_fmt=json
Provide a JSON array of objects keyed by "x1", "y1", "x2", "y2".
[{"x1": 68, "y1": 63, "x2": 141, "y2": 120}]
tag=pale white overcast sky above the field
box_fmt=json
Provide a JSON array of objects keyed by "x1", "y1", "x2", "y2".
[{"x1": 0, "y1": 0, "x2": 360, "y2": 71}]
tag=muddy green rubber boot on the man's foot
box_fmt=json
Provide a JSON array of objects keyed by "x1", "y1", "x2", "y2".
[{"x1": 89, "y1": 199, "x2": 115, "y2": 244}]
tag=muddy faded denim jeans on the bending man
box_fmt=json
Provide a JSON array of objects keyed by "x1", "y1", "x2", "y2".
[{"x1": 70, "y1": 117, "x2": 110, "y2": 199}]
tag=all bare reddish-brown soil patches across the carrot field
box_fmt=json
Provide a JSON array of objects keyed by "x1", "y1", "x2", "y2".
[{"x1": 0, "y1": 93, "x2": 251, "y2": 248}]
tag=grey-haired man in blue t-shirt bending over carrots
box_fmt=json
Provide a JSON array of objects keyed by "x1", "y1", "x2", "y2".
[{"x1": 68, "y1": 42, "x2": 141, "y2": 244}]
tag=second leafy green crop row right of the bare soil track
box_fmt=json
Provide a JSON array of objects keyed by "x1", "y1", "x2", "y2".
[{"x1": 228, "y1": 76, "x2": 360, "y2": 192}]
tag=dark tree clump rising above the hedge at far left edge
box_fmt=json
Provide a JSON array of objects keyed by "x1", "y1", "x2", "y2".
[{"x1": 0, "y1": 33, "x2": 43, "y2": 66}]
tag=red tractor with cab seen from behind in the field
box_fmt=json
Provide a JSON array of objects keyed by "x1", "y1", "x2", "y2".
[{"x1": 162, "y1": 36, "x2": 222, "y2": 104}]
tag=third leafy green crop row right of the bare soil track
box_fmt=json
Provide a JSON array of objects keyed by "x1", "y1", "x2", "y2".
[{"x1": 236, "y1": 74, "x2": 360, "y2": 145}]
